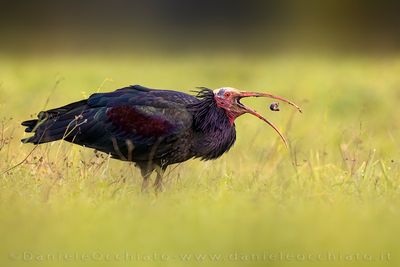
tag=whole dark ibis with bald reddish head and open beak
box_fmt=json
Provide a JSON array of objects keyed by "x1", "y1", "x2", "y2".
[{"x1": 21, "y1": 85, "x2": 301, "y2": 191}]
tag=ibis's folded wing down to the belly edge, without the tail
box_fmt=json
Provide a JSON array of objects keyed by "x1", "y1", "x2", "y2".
[{"x1": 73, "y1": 88, "x2": 196, "y2": 160}]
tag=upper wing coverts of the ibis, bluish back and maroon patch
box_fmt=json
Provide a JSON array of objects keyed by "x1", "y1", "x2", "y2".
[{"x1": 87, "y1": 85, "x2": 198, "y2": 139}]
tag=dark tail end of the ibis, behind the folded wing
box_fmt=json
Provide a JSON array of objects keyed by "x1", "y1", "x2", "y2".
[{"x1": 21, "y1": 100, "x2": 87, "y2": 144}]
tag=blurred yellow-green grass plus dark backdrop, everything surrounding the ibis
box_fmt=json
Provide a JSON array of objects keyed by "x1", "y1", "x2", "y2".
[{"x1": 0, "y1": 0, "x2": 400, "y2": 266}]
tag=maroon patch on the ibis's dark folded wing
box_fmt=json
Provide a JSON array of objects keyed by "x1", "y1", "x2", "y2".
[{"x1": 107, "y1": 106, "x2": 173, "y2": 137}]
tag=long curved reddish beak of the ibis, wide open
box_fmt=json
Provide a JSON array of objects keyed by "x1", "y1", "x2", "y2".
[{"x1": 237, "y1": 91, "x2": 302, "y2": 147}]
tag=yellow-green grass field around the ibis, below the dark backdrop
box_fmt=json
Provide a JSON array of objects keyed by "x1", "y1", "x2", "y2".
[{"x1": 0, "y1": 54, "x2": 400, "y2": 266}]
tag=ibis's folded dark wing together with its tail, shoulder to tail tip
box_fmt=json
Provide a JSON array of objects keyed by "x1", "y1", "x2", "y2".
[{"x1": 23, "y1": 85, "x2": 199, "y2": 160}]
